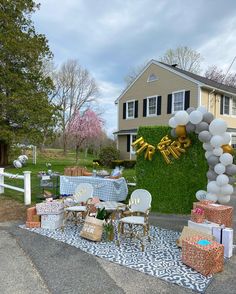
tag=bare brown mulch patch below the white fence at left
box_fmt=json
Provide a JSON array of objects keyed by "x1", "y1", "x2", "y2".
[{"x1": 0, "y1": 196, "x2": 27, "y2": 222}]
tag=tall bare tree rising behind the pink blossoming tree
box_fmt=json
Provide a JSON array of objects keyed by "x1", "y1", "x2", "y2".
[{"x1": 53, "y1": 60, "x2": 98, "y2": 154}]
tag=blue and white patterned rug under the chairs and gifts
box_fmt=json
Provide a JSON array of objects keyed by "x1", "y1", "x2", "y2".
[{"x1": 20, "y1": 224, "x2": 212, "y2": 293}]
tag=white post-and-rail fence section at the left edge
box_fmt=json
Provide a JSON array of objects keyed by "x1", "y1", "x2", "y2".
[{"x1": 0, "y1": 167, "x2": 31, "y2": 205}]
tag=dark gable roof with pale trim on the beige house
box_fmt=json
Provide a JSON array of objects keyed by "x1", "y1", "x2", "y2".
[{"x1": 115, "y1": 59, "x2": 236, "y2": 104}]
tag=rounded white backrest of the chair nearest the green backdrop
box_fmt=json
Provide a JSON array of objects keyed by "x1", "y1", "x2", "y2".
[{"x1": 130, "y1": 189, "x2": 152, "y2": 212}]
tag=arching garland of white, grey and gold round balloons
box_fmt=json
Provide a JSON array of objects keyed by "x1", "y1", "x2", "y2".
[{"x1": 169, "y1": 106, "x2": 236, "y2": 204}]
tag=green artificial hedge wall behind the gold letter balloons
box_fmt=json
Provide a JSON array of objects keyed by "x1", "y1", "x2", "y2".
[{"x1": 136, "y1": 126, "x2": 208, "y2": 214}]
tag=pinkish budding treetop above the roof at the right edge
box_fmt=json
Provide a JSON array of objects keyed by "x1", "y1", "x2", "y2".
[{"x1": 205, "y1": 65, "x2": 236, "y2": 87}]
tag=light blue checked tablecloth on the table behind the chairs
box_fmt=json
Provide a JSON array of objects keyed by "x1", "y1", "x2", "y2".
[{"x1": 60, "y1": 176, "x2": 128, "y2": 201}]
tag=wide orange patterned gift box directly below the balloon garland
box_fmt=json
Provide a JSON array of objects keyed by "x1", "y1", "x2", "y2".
[{"x1": 193, "y1": 202, "x2": 233, "y2": 228}]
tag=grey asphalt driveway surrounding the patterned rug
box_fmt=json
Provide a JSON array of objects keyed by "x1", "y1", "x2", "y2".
[{"x1": 0, "y1": 197, "x2": 236, "y2": 294}]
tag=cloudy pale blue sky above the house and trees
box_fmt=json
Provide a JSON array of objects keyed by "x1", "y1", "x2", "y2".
[{"x1": 33, "y1": 0, "x2": 236, "y2": 136}]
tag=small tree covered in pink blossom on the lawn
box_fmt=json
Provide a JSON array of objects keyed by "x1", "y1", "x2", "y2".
[{"x1": 67, "y1": 109, "x2": 104, "y2": 163}]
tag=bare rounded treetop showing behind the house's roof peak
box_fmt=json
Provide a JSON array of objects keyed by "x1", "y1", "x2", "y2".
[{"x1": 160, "y1": 46, "x2": 203, "y2": 74}]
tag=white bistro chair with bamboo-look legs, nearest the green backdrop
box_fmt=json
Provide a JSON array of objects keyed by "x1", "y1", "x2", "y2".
[{"x1": 117, "y1": 189, "x2": 152, "y2": 251}]
